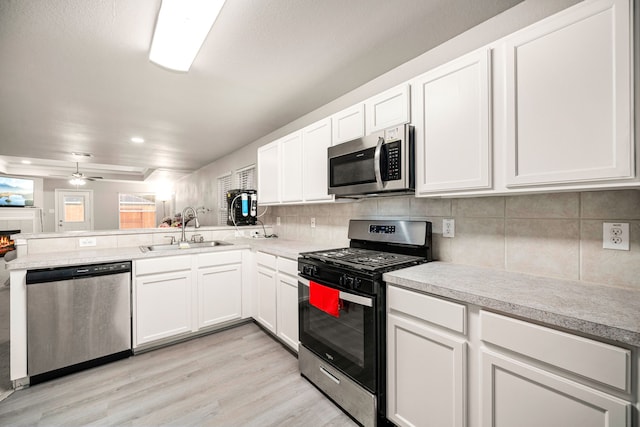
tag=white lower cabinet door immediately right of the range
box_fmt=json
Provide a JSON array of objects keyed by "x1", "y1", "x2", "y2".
[{"x1": 387, "y1": 314, "x2": 468, "y2": 427}]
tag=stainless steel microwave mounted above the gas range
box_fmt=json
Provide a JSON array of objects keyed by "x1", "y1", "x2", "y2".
[{"x1": 327, "y1": 125, "x2": 415, "y2": 197}]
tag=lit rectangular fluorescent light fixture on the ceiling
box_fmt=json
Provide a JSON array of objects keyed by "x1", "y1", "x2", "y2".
[{"x1": 149, "y1": 0, "x2": 224, "y2": 71}]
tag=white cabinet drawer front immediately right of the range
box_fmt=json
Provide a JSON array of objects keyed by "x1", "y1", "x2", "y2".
[{"x1": 387, "y1": 286, "x2": 467, "y2": 334}]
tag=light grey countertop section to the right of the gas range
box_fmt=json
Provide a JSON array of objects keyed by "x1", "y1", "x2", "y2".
[{"x1": 384, "y1": 262, "x2": 640, "y2": 347}]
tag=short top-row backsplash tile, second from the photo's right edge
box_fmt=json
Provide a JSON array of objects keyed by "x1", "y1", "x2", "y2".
[{"x1": 505, "y1": 193, "x2": 580, "y2": 218}]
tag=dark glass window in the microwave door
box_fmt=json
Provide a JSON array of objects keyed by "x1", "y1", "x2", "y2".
[{"x1": 329, "y1": 148, "x2": 376, "y2": 187}]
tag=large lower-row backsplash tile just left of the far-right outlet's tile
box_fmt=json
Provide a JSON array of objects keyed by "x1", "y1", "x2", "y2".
[{"x1": 505, "y1": 219, "x2": 580, "y2": 280}]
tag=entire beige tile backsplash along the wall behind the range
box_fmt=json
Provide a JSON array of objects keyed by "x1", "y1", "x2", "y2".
[{"x1": 272, "y1": 190, "x2": 640, "y2": 288}]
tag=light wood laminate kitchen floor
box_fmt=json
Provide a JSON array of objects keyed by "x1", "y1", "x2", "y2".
[{"x1": 0, "y1": 323, "x2": 356, "y2": 427}]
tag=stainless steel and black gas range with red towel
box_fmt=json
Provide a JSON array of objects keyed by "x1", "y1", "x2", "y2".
[{"x1": 298, "y1": 220, "x2": 432, "y2": 426}]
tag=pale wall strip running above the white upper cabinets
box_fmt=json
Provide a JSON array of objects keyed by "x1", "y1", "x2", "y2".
[{"x1": 175, "y1": 0, "x2": 579, "y2": 225}]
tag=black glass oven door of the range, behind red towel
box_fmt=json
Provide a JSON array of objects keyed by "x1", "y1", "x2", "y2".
[{"x1": 298, "y1": 276, "x2": 379, "y2": 393}]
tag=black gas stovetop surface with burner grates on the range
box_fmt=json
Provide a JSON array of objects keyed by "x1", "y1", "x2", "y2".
[{"x1": 301, "y1": 248, "x2": 426, "y2": 271}]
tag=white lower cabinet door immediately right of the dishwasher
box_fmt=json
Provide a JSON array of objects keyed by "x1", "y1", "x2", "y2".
[{"x1": 134, "y1": 270, "x2": 191, "y2": 345}]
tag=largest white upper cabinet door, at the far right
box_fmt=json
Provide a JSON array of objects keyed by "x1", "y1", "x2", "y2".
[{"x1": 506, "y1": 0, "x2": 634, "y2": 186}]
